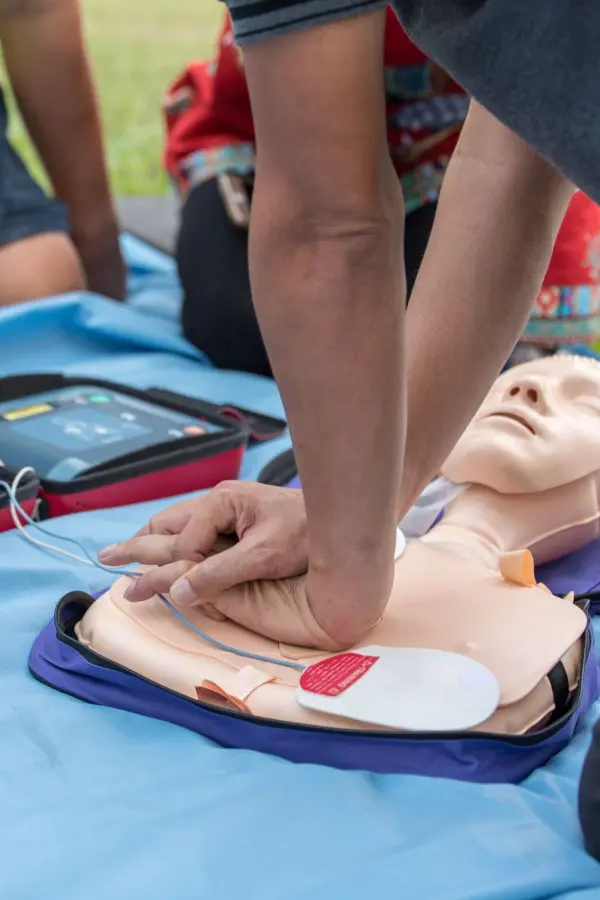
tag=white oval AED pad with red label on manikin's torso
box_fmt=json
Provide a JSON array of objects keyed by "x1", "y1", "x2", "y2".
[{"x1": 296, "y1": 646, "x2": 500, "y2": 732}]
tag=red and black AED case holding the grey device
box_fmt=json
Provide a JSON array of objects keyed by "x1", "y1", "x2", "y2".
[{"x1": 0, "y1": 374, "x2": 286, "y2": 530}]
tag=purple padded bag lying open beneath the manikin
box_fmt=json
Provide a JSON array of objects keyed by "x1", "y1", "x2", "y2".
[{"x1": 29, "y1": 452, "x2": 600, "y2": 783}]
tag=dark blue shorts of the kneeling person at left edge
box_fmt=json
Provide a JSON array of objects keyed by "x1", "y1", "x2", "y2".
[{"x1": 0, "y1": 89, "x2": 69, "y2": 247}]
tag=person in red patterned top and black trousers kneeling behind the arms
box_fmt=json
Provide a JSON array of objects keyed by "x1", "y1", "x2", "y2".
[{"x1": 164, "y1": 7, "x2": 600, "y2": 375}]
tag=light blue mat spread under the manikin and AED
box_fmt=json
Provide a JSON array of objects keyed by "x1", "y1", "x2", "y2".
[{"x1": 0, "y1": 236, "x2": 600, "y2": 900}]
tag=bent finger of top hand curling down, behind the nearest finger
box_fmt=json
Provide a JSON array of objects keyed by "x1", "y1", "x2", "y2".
[{"x1": 174, "y1": 489, "x2": 243, "y2": 562}]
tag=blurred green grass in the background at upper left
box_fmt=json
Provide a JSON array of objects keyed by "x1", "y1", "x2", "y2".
[{"x1": 4, "y1": 0, "x2": 223, "y2": 195}]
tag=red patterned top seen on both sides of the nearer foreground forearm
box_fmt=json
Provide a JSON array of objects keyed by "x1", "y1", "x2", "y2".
[{"x1": 164, "y1": 8, "x2": 468, "y2": 213}]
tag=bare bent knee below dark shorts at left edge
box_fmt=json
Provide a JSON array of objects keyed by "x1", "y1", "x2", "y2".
[{"x1": 0, "y1": 232, "x2": 86, "y2": 306}]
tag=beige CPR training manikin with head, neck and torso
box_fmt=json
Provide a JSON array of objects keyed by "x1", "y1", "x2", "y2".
[{"x1": 77, "y1": 356, "x2": 600, "y2": 734}]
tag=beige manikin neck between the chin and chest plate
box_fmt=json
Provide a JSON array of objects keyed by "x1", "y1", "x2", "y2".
[{"x1": 422, "y1": 475, "x2": 600, "y2": 567}]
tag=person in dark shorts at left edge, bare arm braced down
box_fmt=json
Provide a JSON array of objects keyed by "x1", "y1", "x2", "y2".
[{"x1": 0, "y1": 0, "x2": 125, "y2": 306}]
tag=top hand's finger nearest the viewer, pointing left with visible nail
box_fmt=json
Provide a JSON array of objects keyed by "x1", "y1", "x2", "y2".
[{"x1": 171, "y1": 538, "x2": 271, "y2": 607}]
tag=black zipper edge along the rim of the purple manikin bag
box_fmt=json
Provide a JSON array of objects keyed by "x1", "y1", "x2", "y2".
[{"x1": 49, "y1": 591, "x2": 591, "y2": 747}]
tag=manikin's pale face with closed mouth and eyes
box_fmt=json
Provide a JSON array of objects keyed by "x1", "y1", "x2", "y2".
[{"x1": 442, "y1": 356, "x2": 600, "y2": 494}]
